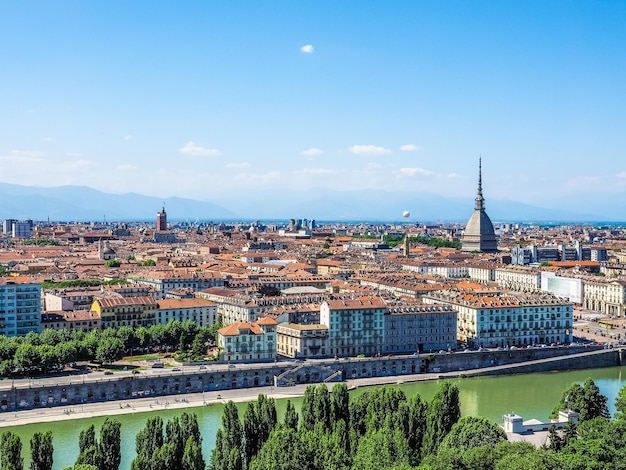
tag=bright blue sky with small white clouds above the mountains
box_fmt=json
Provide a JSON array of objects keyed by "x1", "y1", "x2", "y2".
[{"x1": 0, "y1": 0, "x2": 626, "y2": 211}]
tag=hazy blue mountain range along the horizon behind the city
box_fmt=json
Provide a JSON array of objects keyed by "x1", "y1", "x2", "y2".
[{"x1": 0, "y1": 183, "x2": 623, "y2": 223}]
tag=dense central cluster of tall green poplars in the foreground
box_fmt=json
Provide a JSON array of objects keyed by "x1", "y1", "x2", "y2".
[{"x1": 209, "y1": 382, "x2": 460, "y2": 470}]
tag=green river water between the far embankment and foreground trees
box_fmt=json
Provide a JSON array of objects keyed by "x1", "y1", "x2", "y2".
[{"x1": 0, "y1": 366, "x2": 626, "y2": 470}]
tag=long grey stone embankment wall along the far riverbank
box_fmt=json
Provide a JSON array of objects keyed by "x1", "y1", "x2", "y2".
[{"x1": 0, "y1": 347, "x2": 620, "y2": 411}]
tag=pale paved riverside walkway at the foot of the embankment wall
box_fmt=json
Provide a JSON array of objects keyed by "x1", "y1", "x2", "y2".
[{"x1": 0, "y1": 349, "x2": 626, "y2": 428}]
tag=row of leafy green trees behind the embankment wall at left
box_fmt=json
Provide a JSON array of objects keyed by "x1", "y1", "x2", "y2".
[{"x1": 0, "y1": 320, "x2": 222, "y2": 376}]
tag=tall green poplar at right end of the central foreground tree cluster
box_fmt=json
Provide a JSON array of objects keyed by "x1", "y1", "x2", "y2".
[{"x1": 422, "y1": 382, "x2": 461, "y2": 455}]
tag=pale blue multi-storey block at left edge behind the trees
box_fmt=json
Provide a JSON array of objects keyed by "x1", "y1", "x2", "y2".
[{"x1": 0, "y1": 277, "x2": 41, "y2": 336}]
